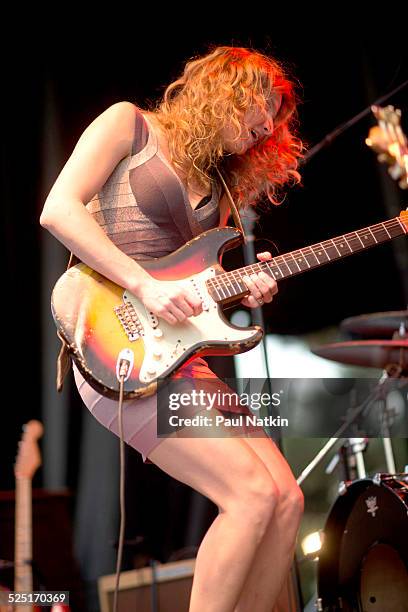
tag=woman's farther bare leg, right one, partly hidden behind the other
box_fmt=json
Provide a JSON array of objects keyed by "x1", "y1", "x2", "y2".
[{"x1": 235, "y1": 434, "x2": 303, "y2": 612}]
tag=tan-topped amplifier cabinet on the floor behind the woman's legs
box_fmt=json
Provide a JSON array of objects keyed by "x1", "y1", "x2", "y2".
[{"x1": 98, "y1": 559, "x2": 195, "y2": 612}]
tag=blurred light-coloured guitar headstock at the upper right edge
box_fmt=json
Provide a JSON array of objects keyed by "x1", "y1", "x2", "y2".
[{"x1": 366, "y1": 106, "x2": 408, "y2": 189}]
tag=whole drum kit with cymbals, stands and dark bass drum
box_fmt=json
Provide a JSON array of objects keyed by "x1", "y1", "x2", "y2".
[{"x1": 298, "y1": 310, "x2": 408, "y2": 612}]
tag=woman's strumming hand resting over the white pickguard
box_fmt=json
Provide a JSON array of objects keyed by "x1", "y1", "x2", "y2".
[{"x1": 134, "y1": 275, "x2": 202, "y2": 325}]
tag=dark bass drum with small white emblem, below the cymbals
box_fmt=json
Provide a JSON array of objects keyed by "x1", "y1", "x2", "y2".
[{"x1": 316, "y1": 474, "x2": 408, "y2": 612}]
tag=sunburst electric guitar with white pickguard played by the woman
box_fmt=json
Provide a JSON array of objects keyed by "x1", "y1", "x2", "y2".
[{"x1": 51, "y1": 106, "x2": 408, "y2": 399}]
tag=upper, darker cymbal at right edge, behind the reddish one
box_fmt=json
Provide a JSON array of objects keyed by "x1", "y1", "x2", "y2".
[{"x1": 340, "y1": 310, "x2": 408, "y2": 338}]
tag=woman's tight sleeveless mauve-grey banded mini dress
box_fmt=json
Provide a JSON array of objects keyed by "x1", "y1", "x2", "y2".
[{"x1": 73, "y1": 106, "x2": 263, "y2": 463}]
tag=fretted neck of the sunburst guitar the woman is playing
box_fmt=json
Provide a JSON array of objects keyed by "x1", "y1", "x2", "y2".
[{"x1": 207, "y1": 213, "x2": 408, "y2": 304}]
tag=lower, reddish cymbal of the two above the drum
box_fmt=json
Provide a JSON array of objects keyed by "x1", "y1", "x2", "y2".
[{"x1": 312, "y1": 338, "x2": 408, "y2": 372}]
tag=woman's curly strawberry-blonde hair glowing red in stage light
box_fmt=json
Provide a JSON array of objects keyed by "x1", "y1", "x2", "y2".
[{"x1": 155, "y1": 46, "x2": 303, "y2": 207}]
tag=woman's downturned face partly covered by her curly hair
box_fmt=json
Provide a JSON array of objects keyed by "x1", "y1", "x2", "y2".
[{"x1": 221, "y1": 93, "x2": 282, "y2": 155}]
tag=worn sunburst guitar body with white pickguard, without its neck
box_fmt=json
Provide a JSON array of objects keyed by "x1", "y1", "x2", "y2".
[{"x1": 52, "y1": 228, "x2": 263, "y2": 398}]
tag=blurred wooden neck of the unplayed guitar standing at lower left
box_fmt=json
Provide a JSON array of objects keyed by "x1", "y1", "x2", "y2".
[{"x1": 14, "y1": 478, "x2": 33, "y2": 592}]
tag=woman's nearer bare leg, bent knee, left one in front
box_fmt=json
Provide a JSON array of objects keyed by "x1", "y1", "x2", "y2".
[{"x1": 149, "y1": 430, "x2": 280, "y2": 612}]
